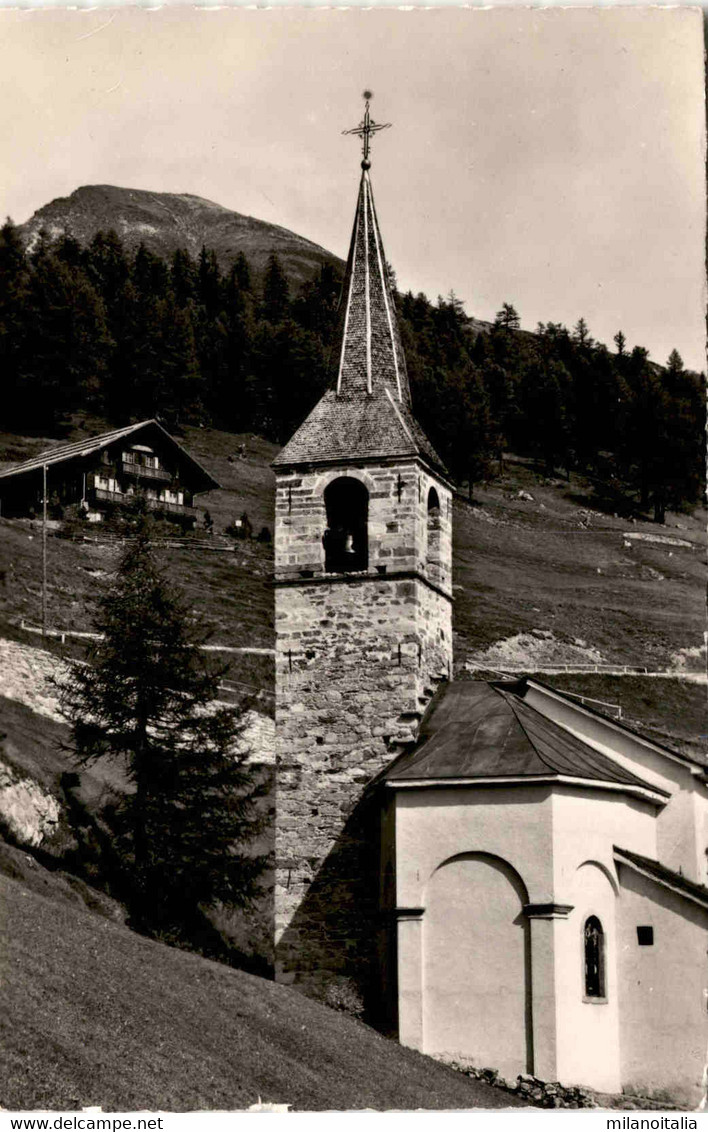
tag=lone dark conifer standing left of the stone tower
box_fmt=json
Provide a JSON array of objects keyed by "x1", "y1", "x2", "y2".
[{"x1": 61, "y1": 501, "x2": 263, "y2": 942}]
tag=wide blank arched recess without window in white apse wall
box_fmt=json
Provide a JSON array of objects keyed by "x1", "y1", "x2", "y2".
[{"x1": 423, "y1": 852, "x2": 532, "y2": 1077}]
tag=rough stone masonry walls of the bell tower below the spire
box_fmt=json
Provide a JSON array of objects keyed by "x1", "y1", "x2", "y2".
[{"x1": 275, "y1": 455, "x2": 452, "y2": 1014}]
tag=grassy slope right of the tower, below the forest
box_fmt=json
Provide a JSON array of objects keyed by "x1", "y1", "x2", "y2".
[{"x1": 453, "y1": 462, "x2": 706, "y2": 669}]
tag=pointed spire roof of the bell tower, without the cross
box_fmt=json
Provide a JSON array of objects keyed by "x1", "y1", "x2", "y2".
[{"x1": 273, "y1": 168, "x2": 445, "y2": 472}]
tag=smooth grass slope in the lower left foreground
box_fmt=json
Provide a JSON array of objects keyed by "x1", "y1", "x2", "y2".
[{"x1": 0, "y1": 848, "x2": 520, "y2": 1112}]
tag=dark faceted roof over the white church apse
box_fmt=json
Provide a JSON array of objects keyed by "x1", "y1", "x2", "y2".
[{"x1": 384, "y1": 680, "x2": 668, "y2": 801}]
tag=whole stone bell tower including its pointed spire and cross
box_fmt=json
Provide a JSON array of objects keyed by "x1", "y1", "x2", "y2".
[{"x1": 273, "y1": 101, "x2": 452, "y2": 1002}]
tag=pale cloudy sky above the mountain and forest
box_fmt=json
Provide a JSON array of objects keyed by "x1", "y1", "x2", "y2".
[{"x1": 0, "y1": 6, "x2": 706, "y2": 369}]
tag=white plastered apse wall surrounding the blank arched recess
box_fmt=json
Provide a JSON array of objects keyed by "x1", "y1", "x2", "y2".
[{"x1": 395, "y1": 784, "x2": 656, "y2": 1091}]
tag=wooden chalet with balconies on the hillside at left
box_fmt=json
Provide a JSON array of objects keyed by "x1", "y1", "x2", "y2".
[{"x1": 0, "y1": 420, "x2": 220, "y2": 529}]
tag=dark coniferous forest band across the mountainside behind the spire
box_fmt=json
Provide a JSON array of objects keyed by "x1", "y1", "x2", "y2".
[{"x1": 0, "y1": 221, "x2": 705, "y2": 522}]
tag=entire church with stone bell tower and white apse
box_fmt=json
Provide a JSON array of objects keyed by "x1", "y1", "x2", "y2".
[{"x1": 266, "y1": 102, "x2": 708, "y2": 1105}]
